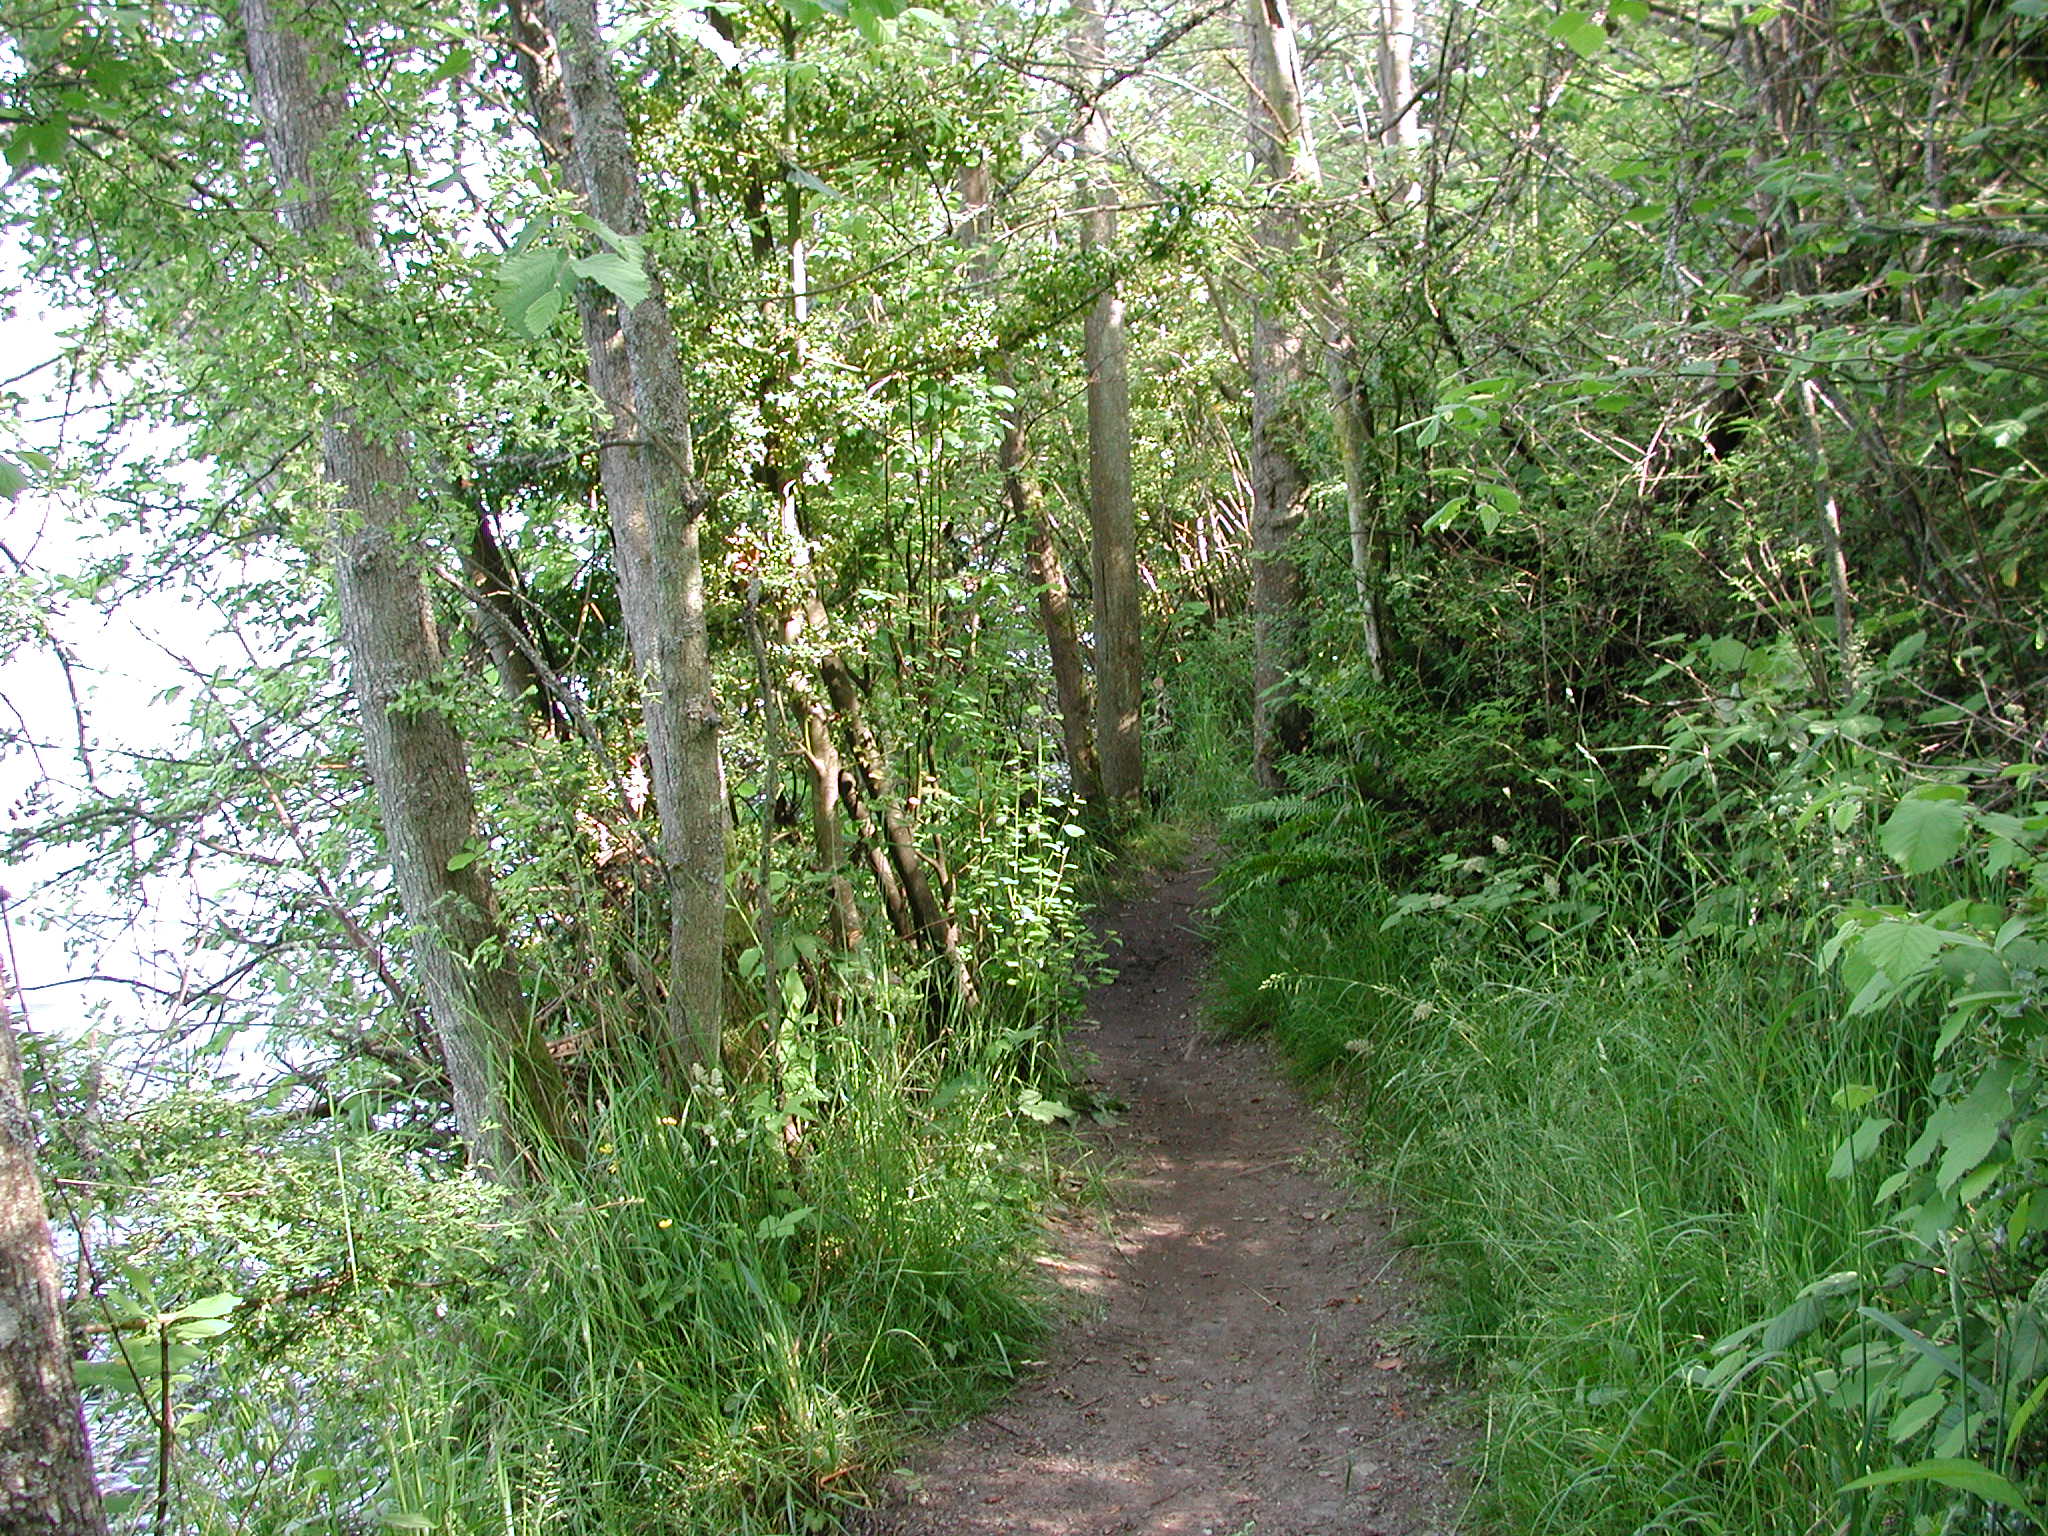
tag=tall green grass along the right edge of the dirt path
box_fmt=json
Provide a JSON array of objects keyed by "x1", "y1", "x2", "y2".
[{"x1": 1217, "y1": 831, "x2": 1921, "y2": 1536}]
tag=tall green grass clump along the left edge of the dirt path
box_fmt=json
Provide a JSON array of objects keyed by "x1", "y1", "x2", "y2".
[{"x1": 378, "y1": 1020, "x2": 1040, "y2": 1536}]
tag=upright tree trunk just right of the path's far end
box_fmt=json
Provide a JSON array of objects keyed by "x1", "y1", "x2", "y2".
[{"x1": 1249, "y1": 0, "x2": 1319, "y2": 788}]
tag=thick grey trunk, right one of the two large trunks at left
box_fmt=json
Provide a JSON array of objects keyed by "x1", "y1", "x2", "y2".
[{"x1": 543, "y1": 0, "x2": 725, "y2": 1071}]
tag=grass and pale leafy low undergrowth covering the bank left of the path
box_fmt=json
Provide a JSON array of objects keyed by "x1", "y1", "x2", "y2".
[{"x1": 35, "y1": 881, "x2": 1090, "y2": 1536}]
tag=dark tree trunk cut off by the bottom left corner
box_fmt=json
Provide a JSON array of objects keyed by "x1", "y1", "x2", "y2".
[{"x1": 0, "y1": 969, "x2": 106, "y2": 1536}]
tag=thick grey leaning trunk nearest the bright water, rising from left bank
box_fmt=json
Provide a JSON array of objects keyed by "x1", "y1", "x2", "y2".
[{"x1": 242, "y1": 0, "x2": 567, "y2": 1178}]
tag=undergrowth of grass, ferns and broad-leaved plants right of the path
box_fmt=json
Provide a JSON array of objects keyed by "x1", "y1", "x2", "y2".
[{"x1": 1187, "y1": 630, "x2": 2048, "y2": 1536}]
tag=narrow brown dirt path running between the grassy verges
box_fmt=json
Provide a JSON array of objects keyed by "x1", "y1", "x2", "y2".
[{"x1": 872, "y1": 868, "x2": 1470, "y2": 1536}]
